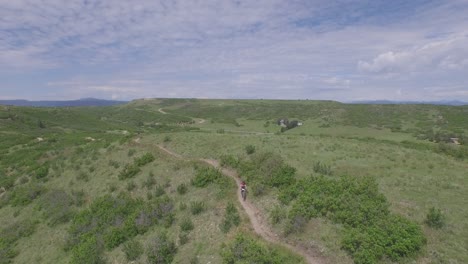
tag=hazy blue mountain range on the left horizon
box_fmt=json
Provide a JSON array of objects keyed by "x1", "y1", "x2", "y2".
[{"x1": 0, "y1": 98, "x2": 128, "y2": 107}]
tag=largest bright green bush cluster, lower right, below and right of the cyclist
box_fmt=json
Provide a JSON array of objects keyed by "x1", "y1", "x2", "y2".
[{"x1": 282, "y1": 176, "x2": 426, "y2": 263}]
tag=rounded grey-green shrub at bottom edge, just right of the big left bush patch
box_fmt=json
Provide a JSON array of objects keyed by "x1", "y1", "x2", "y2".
[{"x1": 147, "y1": 233, "x2": 177, "y2": 264}]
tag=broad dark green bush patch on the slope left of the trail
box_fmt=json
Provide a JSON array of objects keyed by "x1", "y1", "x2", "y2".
[{"x1": 67, "y1": 194, "x2": 174, "y2": 263}]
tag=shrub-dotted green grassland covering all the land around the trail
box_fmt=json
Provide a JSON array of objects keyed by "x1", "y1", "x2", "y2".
[{"x1": 0, "y1": 99, "x2": 468, "y2": 263}]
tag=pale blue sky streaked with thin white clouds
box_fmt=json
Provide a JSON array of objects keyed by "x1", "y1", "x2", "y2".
[{"x1": 0, "y1": 0, "x2": 468, "y2": 102}]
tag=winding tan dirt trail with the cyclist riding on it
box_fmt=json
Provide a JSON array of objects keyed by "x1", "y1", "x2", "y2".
[{"x1": 158, "y1": 146, "x2": 327, "y2": 264}]
